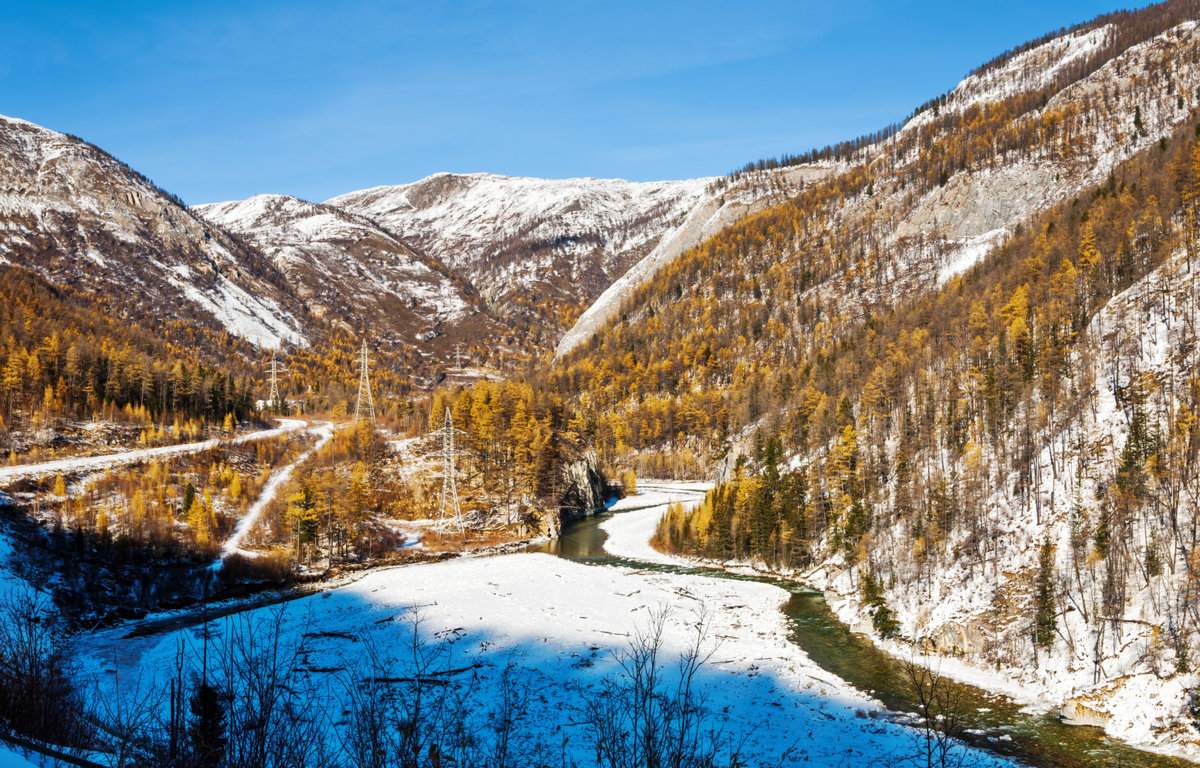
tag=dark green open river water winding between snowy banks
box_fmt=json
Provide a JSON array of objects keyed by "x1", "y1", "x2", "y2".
[{"x1": 532, "y1": 504, "x2": 1196, "y2": 768}]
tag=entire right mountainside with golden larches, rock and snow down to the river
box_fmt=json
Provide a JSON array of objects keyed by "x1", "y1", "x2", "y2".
[{"x1": 551, "y1": 2, "x2": 1200, "y2": 743}]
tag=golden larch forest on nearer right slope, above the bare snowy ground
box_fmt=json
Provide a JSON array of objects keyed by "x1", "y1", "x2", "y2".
[{"x1": 664, "y1": 118, "x2": 1200, "y2": 565}]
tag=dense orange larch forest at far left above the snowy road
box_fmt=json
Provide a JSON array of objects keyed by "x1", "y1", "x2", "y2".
[{"x1": 0, "y1": 265, "x2": 262, "y2": 424}]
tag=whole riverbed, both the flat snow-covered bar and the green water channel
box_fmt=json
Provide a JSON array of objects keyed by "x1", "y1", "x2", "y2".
[{"x1": 77, "y1": 486, "x2": 1193, "y2": 768}]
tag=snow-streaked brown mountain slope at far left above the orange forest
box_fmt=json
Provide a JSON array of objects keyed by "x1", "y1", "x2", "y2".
[{"x1": 0, "y1": 116, "x2": 306, "y2": 347}]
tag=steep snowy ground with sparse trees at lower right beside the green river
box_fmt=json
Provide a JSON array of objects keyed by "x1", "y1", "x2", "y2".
[{"x1": 808, "y1": 242, "x2": 1200, "y2": 760}]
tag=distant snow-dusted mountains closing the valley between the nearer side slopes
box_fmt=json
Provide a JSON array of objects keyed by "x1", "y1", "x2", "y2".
[{"x1": 177, "y1": 168, "x2": 801, "y2": 365}]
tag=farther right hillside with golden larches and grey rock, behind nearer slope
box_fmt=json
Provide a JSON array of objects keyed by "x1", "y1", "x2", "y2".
[{"x1": 554, "y1": 6, "x2": 1200, "y2": 475}]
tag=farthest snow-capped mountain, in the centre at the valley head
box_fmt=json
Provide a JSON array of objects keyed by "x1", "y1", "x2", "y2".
[{"x1": 326, "y1": 173, "x2": 713, "y2": 336}]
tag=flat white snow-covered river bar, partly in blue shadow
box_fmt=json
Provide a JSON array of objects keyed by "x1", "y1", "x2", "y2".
[{"x1": 80, "y1": 487, "x2": 1006, "y2": 766}]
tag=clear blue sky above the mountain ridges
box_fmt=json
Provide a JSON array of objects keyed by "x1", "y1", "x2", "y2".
[{"x1": 0, "y1": 0, "x2": 1132, "y2": 203}]
